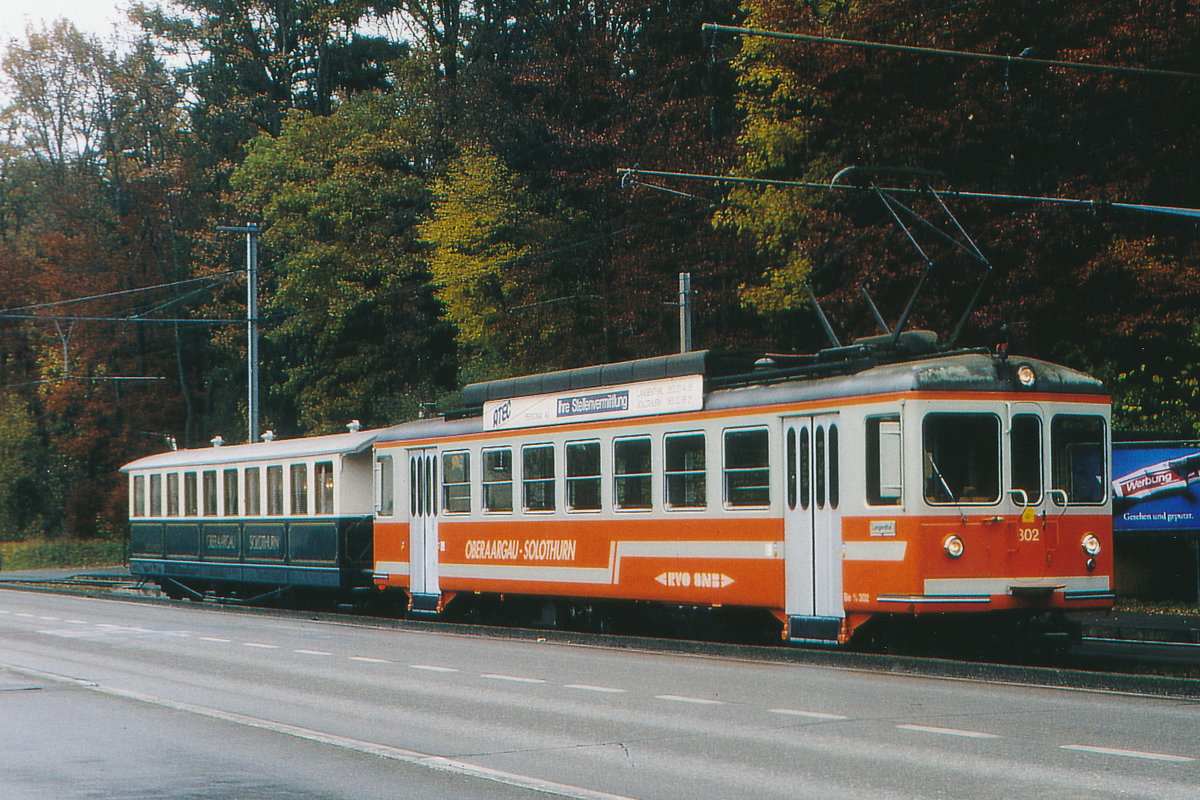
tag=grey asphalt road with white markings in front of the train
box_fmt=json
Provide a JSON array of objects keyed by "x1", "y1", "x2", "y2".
[{"x1": 0, "y1": 589, "x2": 1200, "y2": 800}]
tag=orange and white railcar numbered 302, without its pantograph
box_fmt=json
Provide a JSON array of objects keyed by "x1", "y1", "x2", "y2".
[{"x1": 374, "y1": 333, "x2": 1112, "y2": 643}]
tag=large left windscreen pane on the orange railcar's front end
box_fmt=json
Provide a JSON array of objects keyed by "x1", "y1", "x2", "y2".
[{"x1": 924, "y1": 413, "x2": 1000, "y2": 505}]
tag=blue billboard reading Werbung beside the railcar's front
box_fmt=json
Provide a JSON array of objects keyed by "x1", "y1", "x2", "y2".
[{"x1": 1112, "y1": 443, "x2": 1200, "y2": 531}]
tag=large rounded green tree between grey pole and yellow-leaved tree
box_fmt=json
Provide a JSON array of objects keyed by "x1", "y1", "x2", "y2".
[{"x1": 233, "y1": 94, "x2": 454, "y2": 432}]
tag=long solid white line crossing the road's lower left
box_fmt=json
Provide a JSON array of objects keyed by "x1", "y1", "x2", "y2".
[{"x1": 0, "y1": 664, "x2": 635, "y2": 800}]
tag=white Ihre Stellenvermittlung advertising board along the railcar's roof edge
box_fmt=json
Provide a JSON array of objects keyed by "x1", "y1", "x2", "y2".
[{"x1": 484, "y1": 375, "x2": 704, "y2": 431}]
